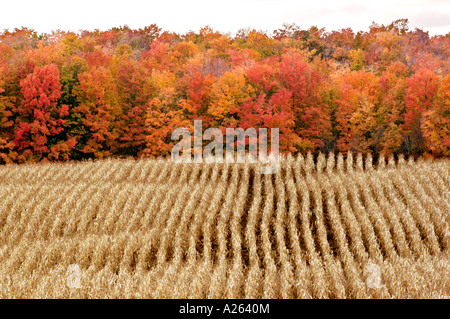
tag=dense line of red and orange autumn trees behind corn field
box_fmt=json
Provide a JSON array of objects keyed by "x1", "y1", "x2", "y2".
[{"x1": 0, "y1": 19, "x2": 450, "y2": 163}]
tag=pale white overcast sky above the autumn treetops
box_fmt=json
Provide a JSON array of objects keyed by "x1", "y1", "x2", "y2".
[{"x1": 0, "y1": 0, "x2": 450, "y2": 35}]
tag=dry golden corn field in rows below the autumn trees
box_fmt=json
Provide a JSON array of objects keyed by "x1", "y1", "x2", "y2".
[{"x1": 0, "y1": 153, "x2": 450, "y2": 298}]
